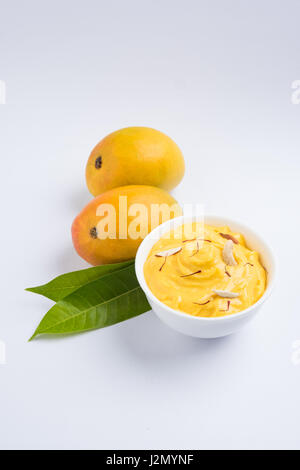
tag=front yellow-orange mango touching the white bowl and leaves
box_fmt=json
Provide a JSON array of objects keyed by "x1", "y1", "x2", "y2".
[{"x1": 72, "y1": 185, "x2": 182, "y2": 266}]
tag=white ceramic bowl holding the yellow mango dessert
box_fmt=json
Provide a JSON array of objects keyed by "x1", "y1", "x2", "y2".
[{"x1": 135, "y1": 216, "x2": 275, "y2": 338}]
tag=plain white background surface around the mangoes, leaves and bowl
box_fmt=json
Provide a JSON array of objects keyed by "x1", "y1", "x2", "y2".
[{"x1": 0, "y1": 0, "x2": 300, "y2": 449}]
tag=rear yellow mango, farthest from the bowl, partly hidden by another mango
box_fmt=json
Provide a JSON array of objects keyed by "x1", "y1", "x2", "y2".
[{"x1": 86, "y1": 127, "x2": 185, "y2": 196}]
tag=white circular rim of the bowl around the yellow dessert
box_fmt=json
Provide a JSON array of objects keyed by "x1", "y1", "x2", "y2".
[{"x1": 135, "y1": 214, "x2": 277, "y2": 322}]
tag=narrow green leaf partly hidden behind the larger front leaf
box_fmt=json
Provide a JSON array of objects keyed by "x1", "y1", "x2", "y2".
[{"x1": 26, "y1": 259, "x2": 134, "y2": 302}]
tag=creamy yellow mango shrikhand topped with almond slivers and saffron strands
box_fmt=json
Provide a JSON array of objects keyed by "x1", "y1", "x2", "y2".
[{"x1": 144, "y1": 223, "x2": 267, "y2": 317}]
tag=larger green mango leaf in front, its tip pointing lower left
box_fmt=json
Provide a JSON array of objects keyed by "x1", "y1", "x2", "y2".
[{"x1": 30, "y1": 265, "x2": 151, "y2": 340}]
